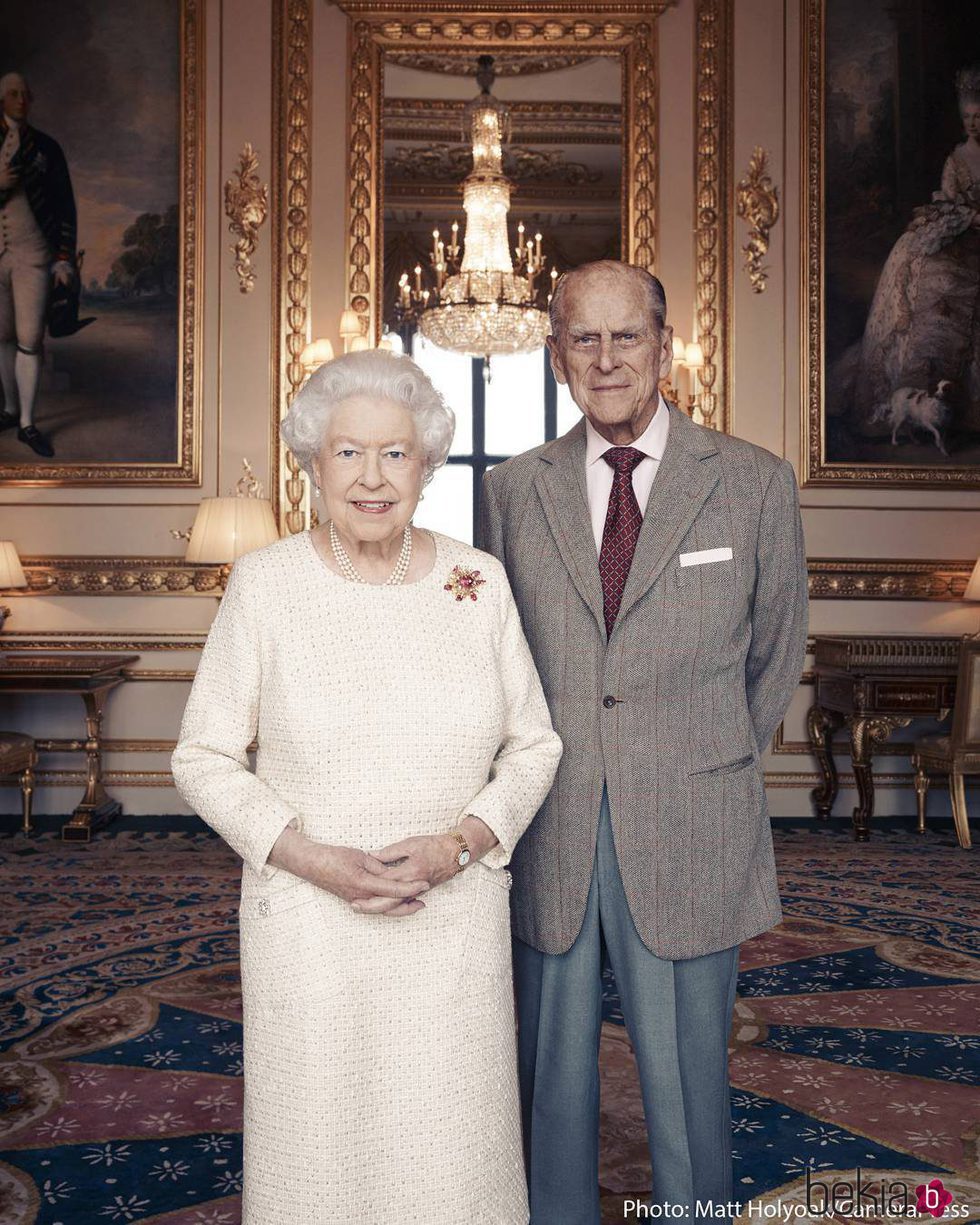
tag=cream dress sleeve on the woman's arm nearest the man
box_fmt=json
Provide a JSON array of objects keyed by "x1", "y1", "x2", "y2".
[{"x1": 463, "y1": 566, "x2": 561, "y2": 867}]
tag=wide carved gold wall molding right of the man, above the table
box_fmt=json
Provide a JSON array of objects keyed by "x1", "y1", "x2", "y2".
[{"x1": 806, "y1": 557, "x2": 974, "y2": 601}]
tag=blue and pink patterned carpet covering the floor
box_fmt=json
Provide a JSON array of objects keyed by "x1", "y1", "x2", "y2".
[{"x1": 0, "y1": 824, "x2": 980, "y2": 1225}]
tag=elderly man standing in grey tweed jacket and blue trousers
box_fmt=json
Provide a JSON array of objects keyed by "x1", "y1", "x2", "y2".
[{"x1": 483, "y1": 261, "x2": 806, "y2": 1225}]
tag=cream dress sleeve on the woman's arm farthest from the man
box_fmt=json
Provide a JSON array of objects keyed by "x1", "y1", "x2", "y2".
[{"x1": 170, "y1": 559, "x2": 300, "y2": 878}]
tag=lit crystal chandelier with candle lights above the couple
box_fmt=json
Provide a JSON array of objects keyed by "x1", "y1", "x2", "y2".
[{"x1": 396, "y1": 55, "x2": 557, "y2": 377}]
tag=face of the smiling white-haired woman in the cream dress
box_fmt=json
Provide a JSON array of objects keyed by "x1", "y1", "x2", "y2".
[{"x1": 316, "y1": 396, "x2": 425, "y2": 543}]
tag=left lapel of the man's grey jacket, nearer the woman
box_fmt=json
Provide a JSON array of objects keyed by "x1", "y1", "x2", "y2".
[{"x1": 535, "y1": 418, "x2": 605, "y2": 637}]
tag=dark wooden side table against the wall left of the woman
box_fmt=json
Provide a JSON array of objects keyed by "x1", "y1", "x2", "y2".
[{"x1": 0, "y1": 650, "x2": 140, "y2": 842}]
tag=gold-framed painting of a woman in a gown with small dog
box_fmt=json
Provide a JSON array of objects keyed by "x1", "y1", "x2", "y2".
[{"x1": 800, "y1": 0, "x2": 980, "y2": 490}]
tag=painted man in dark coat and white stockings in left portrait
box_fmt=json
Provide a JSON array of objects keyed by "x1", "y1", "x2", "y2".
[{"x1": 0, "y1": 72, "x2": 76, "y2": 457}]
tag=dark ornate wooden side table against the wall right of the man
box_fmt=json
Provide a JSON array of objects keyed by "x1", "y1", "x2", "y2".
[{"x1": 807, "y1": 635, "x2": 960, "y2": 842}]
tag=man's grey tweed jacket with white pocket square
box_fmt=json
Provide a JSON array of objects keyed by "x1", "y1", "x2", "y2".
[{"x1": 481, "y1": 409, "x2": 807, "y2": 959}]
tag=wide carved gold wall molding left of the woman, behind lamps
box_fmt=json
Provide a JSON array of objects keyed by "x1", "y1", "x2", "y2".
[{"x1": 12, "y1": 557, "x2": 228, "y2": 595}]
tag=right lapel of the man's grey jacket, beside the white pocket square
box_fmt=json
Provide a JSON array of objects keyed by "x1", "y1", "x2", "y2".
[{"x1": 616, "y1": 408, "x2": 719, "y2": 625}]
